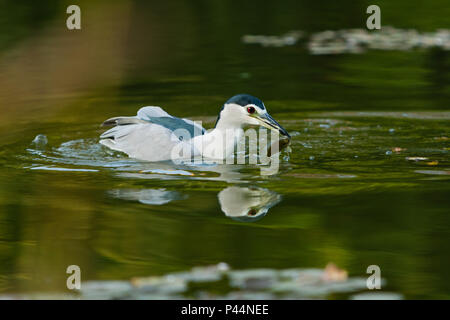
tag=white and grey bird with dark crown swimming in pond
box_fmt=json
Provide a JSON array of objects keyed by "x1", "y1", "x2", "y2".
[{"x1": 100, "y1": 94, "x2": 291, "y2": 162}]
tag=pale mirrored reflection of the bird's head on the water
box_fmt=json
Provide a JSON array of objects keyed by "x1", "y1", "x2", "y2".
[{"x1": 217, "y1": 186, "x2": 281, "y2": 222}]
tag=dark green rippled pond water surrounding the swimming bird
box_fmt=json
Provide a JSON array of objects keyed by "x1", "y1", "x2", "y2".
[{"x1": 0, "y1": 1, "x2": 450, "y2": 298}]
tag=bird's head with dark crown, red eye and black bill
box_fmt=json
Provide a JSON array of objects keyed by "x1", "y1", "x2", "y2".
[{"x1": 216, "y1": 94, "x2": 291, "y2": 139}]
